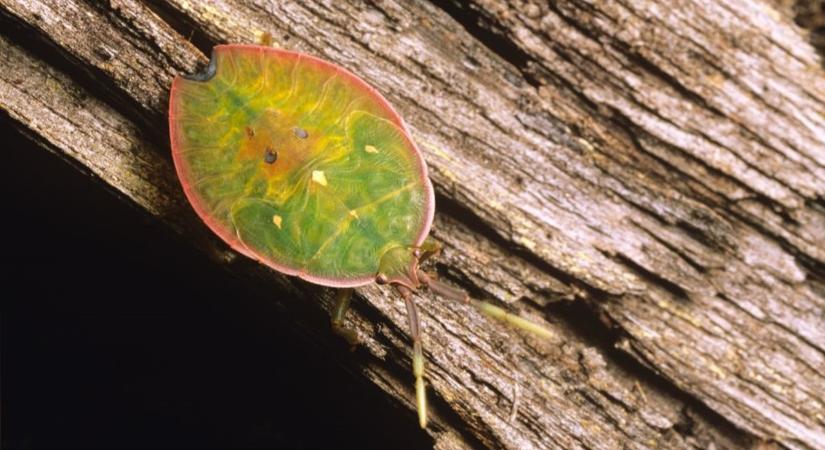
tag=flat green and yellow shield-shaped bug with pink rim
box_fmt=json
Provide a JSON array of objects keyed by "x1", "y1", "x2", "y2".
[{"x1": 169, "y1": 45, "x2": 549, "y2": 428}]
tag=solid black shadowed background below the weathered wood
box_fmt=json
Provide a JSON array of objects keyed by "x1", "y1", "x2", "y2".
[{"x1": 0, "y1": 121, "x2": 432, "y2": 450}]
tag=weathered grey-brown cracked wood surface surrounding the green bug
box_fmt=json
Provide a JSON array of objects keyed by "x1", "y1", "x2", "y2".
[{"x1": 0, "y1": 0, "x2": 825, "y2": 449}]
